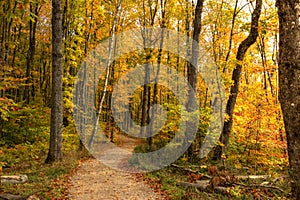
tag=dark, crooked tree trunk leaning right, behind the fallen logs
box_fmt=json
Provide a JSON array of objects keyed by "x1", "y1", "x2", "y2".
[{"x1": 213, "y1": 0, "x2": 262, "y2": 160}]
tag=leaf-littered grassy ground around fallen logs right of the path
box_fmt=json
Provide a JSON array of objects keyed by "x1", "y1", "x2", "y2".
[{"x1": 135, "y1": 143, "x2": 290, "y2": 200}]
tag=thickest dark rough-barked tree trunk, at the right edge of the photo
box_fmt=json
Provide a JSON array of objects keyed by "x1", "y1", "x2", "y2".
[{"x1": 276, "y1": 0, "x2": 300, "y2": 199}]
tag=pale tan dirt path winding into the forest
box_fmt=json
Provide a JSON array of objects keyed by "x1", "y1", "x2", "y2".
[{"x1": 69, "y1": 135, "x2": 165, "y2": 200}]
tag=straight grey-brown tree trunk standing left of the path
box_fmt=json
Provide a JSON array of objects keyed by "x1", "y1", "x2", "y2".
[{"x1": 45, "y1": 0, "x2": 63, "y2": 163}]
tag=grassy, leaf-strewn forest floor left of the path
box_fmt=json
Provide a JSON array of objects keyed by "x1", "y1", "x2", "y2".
[{"x1": 0, "y1": 114, "x2": 89, "y2": 200}]
